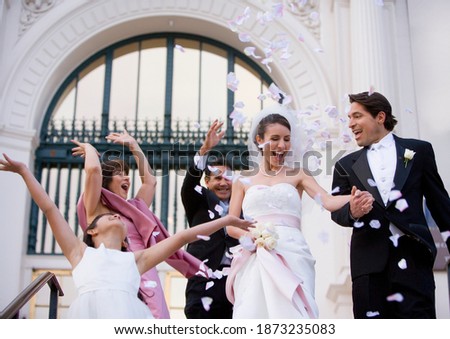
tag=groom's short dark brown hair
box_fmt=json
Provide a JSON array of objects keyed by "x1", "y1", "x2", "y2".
[{"x1": 348, "y1": 92, "x2": 397, "y2": 131}]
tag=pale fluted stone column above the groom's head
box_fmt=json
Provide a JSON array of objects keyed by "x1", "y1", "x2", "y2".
[{"x1": 350, "y1": 0, "x2": 390, "y2": 93}]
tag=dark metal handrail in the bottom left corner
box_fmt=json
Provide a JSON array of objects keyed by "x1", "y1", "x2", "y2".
[{"x1": 0, "y1": 272, "x2": 64, "y2": 319}]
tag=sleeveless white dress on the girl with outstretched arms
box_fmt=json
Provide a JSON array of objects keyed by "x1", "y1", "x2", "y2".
[{"x1": 67, "y1": 244, "x2": 153, "y2": 319}]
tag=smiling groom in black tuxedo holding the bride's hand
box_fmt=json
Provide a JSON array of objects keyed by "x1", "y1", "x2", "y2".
[{"x1": 332, "y1": 92, "x2": 450, "y2": 318}]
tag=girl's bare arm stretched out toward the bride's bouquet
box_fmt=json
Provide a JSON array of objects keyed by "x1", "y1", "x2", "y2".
[{"x1": 134, "y1": 215, "x2": 254, "y2": 274}]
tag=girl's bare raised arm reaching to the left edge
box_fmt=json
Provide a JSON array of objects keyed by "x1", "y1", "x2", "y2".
[{"x1": 0, "y1": 154, "x2": 86, "y2": 267}]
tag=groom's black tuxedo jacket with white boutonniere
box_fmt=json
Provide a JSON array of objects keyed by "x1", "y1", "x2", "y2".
[{"x1": 331, "y1": 135, "x2": 450, "y2": 278}]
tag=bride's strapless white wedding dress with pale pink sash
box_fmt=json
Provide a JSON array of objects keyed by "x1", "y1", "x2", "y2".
[{"x1": 227, "y1": 183, "x2": 318, "y2": 319}]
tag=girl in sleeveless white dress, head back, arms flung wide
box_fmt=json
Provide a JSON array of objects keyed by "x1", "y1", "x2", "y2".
[{"x1": 0, "y1": 154, "x2": 253, "y2": 319}]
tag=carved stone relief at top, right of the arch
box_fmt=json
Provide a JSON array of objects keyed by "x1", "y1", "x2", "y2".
[{"x1": 285, "y1": 0, "x2": 320, "y2": 40}]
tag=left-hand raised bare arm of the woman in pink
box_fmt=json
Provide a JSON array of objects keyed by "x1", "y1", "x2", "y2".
[{"x1": 72, "y1": 140, "x2": 102, "y2": 225}]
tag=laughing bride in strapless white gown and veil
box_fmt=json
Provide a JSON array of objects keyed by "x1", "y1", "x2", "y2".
[{"x1": 227, "y1": 105, "x2": 373, "y2": 319}]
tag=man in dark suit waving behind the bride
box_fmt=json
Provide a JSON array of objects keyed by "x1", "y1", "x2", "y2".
[{"x1": 181, "y1": 120, "x2": 239, "y2": 319}]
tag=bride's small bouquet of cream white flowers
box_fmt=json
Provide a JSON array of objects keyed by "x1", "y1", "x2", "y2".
[{"x1": 239, "y1": 223, "x2": 278, "y2": 252}]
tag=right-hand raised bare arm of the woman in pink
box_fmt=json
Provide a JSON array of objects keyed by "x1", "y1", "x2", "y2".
[{"x1": 106, "y1": 130, "x2": 156, "y2": 207}]
